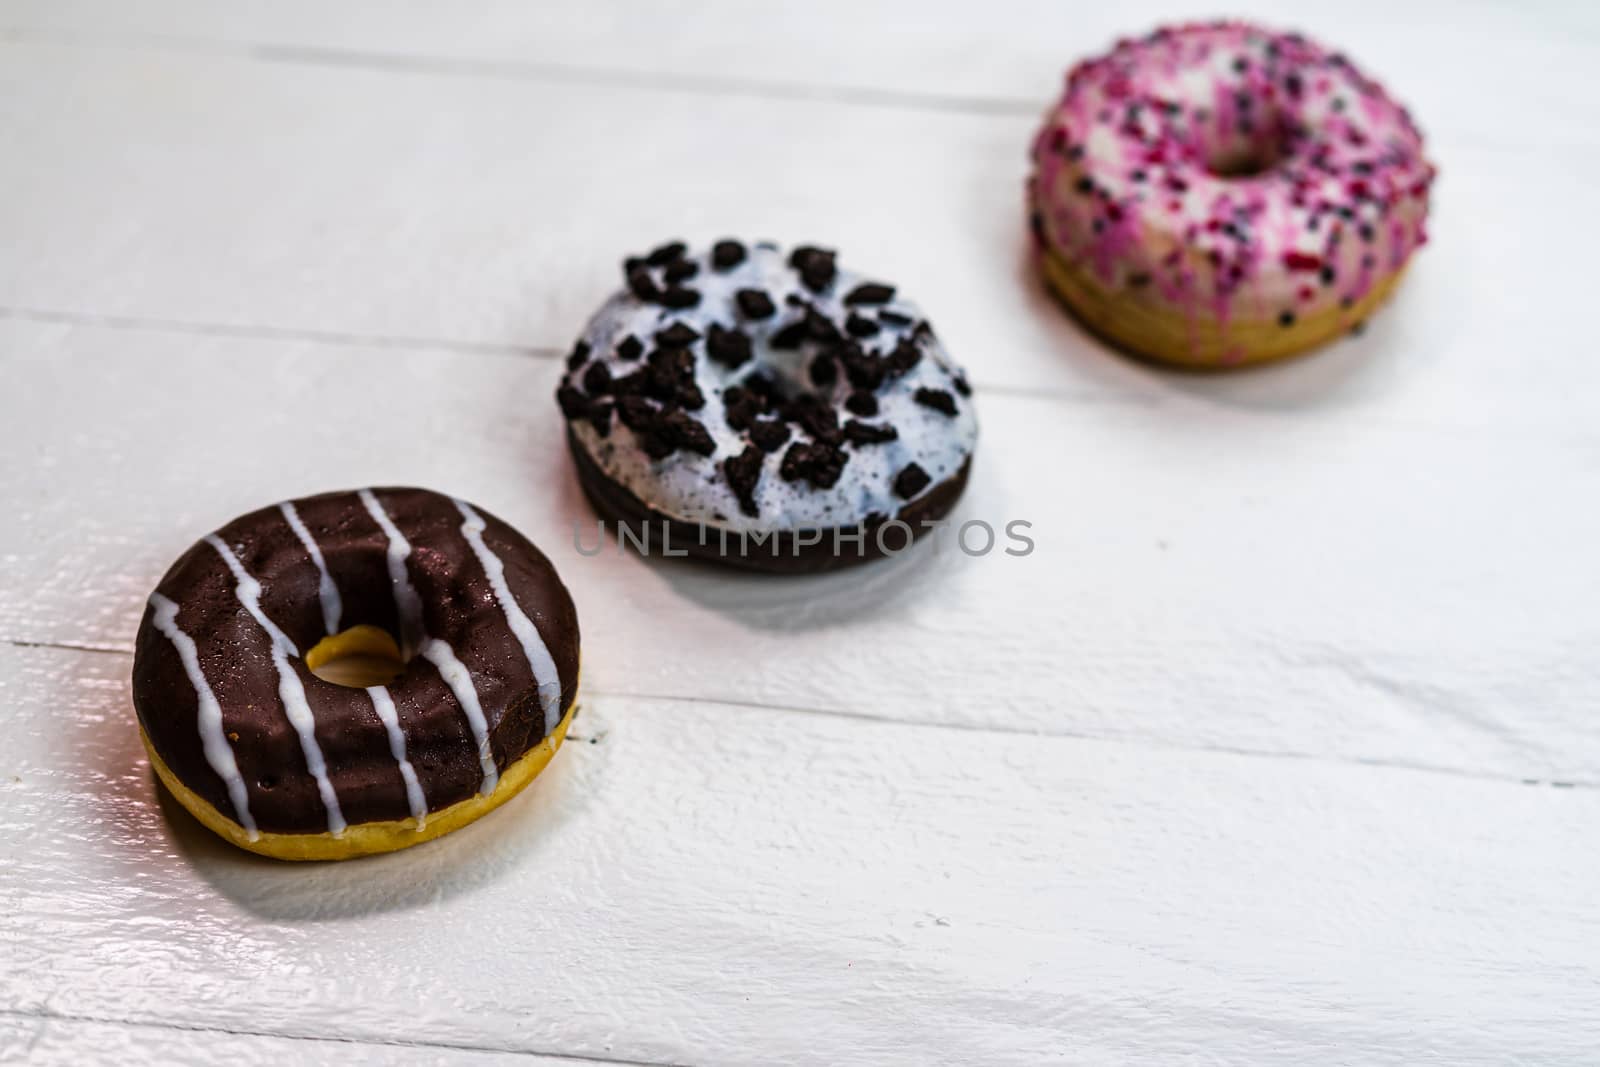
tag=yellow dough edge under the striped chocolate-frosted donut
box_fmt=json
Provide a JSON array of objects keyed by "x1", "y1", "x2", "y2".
[{"x1": 139, "y1": 694, "x2": 578, "y2": 862}]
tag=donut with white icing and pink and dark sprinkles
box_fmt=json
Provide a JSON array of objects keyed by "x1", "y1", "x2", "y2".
[{"x1": 1027, "y1": 22, "x2": 1435, "y2": 368}]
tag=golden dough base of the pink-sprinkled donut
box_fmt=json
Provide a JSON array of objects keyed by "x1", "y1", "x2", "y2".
[{"x1": 1037, "y1": 239, "x2": 1410, "y2": 371}]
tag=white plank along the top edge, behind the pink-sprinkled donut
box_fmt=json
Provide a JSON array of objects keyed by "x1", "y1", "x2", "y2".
[{"x1": 0, "y1": 0, "x2": 1600, "y2": 147}]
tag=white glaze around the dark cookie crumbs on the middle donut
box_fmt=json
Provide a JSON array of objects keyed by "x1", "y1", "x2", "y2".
[{"x1": 568, "y1": 245, "x2": 978, "y2": 531}]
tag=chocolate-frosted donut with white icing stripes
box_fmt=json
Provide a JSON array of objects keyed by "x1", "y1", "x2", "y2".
[{"x1": 133, "y1": 488, "x2": 578, "y2": 859}]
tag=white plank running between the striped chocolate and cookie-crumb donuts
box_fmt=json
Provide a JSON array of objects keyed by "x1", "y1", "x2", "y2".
[{"x1": 0, "y1": 323, "x2": 1600, "y2": 781}]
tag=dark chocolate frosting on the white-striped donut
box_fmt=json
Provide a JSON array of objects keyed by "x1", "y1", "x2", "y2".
[{"x1": 133, "y1": 488, "x2": 578, "y2": 833}]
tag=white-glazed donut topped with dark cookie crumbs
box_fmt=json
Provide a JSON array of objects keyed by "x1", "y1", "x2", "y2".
[{"x1": 557, "y1": 240, "x2": 978, "y2": 573}]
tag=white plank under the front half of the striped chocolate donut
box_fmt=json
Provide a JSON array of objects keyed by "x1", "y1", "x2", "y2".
[{"x1": 0, "y1": 649, "x2": 1600, "y2": 1065}]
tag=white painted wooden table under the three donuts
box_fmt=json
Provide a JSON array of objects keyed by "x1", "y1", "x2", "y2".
[{"x1": 0, "y1": 0, "x2": 1600, "y2": 1065}]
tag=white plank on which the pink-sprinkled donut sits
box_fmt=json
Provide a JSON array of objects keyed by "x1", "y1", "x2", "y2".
[{"x1": 0, "y1": 35, "x2": 1600, "y2": 429}]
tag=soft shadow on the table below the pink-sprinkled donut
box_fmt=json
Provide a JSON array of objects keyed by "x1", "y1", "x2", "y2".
[{"x1": 1014, "y1": 233, "x2": 1418, "y2": 413}]
